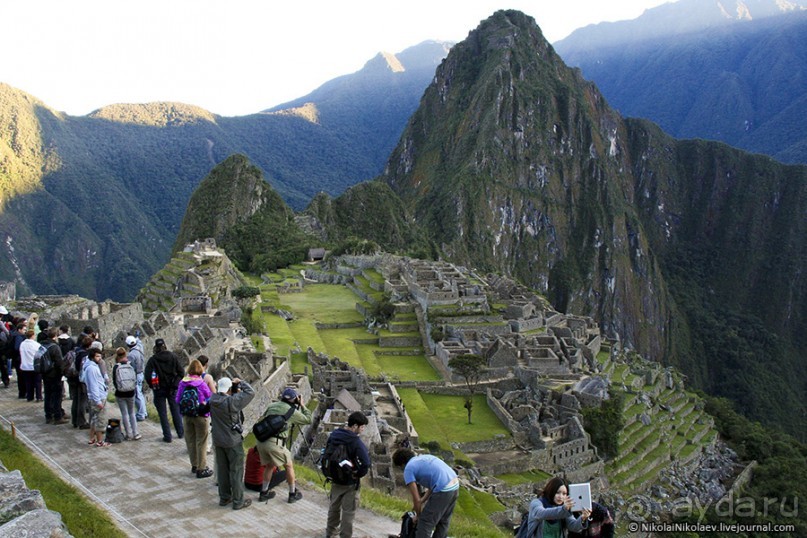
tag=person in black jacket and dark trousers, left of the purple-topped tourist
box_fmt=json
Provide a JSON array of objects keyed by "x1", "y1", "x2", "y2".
[{"x1": 143, "y1": 338, "x2": 185, "y2": 443}]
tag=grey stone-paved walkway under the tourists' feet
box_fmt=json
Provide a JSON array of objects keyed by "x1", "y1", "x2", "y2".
[{"x1": 0, "y1": 381, "x2": 399, "y2": 538}]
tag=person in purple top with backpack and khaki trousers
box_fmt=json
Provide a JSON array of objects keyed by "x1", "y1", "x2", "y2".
[{"x1": 176, "y1": 359, "x2": 213, "y2": 478}]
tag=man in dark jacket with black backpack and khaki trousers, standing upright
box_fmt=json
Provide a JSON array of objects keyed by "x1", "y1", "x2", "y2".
[{"x1": 321, "y1": 411, "x2": 370, "y2": 538}]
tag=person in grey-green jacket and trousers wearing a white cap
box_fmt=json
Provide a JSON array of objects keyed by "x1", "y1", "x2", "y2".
[{"x1": 210, "y1": 377, "x2": 255, "y2": 510}]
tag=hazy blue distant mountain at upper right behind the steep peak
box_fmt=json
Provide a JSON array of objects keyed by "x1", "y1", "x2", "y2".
[{"x1": 555, "y1": 0, "x2": 807, "y2": 163}]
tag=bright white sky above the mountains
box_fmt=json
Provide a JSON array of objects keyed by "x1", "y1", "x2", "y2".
[{"x1": 0, "y1": 0, "x2": 668, "y2": 116}]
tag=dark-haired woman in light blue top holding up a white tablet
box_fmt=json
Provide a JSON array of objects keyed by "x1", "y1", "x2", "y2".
[{"x1": 527, "y1": 476, "x2": 591, "y2": 538}]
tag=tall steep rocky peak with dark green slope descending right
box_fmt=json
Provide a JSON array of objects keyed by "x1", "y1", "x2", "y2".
[{"x1": 382, "y1": 11, "x2": 807, "y2": 437}]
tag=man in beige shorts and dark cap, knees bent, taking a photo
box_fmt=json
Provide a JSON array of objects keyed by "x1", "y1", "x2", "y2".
[{"x1": 257, "y1": 387, "x2": 311, "y2": 503}]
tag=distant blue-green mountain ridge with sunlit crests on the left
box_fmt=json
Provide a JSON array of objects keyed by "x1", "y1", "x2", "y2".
[{"x1": 0, "y1": 42, "x2": 448, "y2": 300}]
